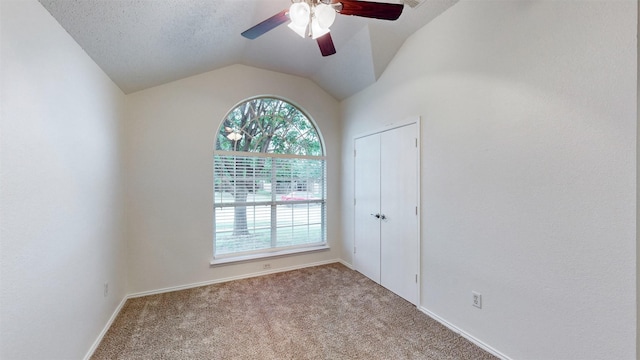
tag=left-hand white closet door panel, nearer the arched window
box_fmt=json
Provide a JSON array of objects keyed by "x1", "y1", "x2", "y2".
[{"x1": 354, "y1": 134, "x2": 380, "y2": 283}]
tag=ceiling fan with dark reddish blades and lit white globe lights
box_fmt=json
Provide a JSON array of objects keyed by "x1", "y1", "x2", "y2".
[{"x1": 241, "y1": 0, "x2": 404, "y2": 56}]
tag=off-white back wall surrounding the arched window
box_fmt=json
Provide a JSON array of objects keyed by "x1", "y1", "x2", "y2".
[{"x1": 126, "y1": 65, "x2": 341, "y2": 293}]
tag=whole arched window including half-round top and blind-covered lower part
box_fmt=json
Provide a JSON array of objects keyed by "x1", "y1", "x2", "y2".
[{"x1": 213, "y1": 97, "x2": 326, "y2": 259}]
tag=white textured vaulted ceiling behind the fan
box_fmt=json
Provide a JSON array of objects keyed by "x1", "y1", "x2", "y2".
[{"x1": 40, "y1": 0, "x2": 458, "y2": 100}]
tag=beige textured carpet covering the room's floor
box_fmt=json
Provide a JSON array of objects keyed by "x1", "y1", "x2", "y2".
[{"x1": 93, "y1": 264, "x2": 495, "y2": 360}]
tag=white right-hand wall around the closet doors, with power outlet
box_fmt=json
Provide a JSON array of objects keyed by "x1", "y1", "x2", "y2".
[{"x1": 342, "y1": 1, "x2": 637, "y2": 360}]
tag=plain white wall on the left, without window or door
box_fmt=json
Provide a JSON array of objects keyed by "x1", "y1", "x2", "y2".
[{"x1": 0, "y1": 0, "x2": 126, "y2": 359}]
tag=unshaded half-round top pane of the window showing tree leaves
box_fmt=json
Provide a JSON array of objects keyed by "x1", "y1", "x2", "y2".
[{"x1": 216, "y1": 97, "x2": 323, "y2": 156}]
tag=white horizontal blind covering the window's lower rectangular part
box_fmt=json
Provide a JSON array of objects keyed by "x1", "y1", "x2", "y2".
[{"x1": 214, "y1": 151, "x2": 326, "y2": 258}]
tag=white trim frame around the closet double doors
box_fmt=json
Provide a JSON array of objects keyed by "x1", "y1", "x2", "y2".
[{"x1": 351, "y1": 115, "x2": 422, "y2": 307}]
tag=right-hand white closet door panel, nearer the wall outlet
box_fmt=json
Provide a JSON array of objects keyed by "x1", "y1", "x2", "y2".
[{"x1": 380, "y1": 124, "x2": 419, "y2": 304}]
